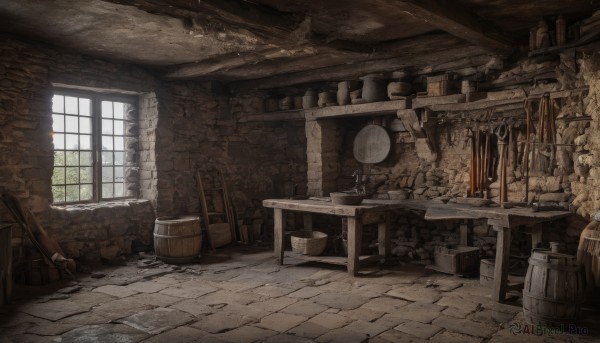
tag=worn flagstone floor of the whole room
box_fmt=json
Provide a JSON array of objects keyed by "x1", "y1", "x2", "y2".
[{"x1": 0, "y1": 247, "x2": 600, "y2": 343}]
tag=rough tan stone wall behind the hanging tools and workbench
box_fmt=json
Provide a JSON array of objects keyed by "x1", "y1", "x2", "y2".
[{"x1": 307, "y1": 53, "x2": 600, "y2": 258}]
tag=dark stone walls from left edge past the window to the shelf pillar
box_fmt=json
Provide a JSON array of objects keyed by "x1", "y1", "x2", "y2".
[{"x1": 0, "y1": 35, "x2": 307, "y2": 266}]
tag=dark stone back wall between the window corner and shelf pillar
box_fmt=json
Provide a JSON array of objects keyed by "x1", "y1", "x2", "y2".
[{"x1": 155, "y1": 82, "x2": 306, "y2": 223}]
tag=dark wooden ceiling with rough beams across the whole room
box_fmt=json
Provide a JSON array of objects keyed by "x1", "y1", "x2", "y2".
[{"x1": 0, "y1": 0, "x2": 600, "y2": 88}]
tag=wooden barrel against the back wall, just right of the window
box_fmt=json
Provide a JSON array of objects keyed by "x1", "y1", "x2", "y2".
[{"x1": 154, "y1": 216, "x2": 202, "y2": 263}]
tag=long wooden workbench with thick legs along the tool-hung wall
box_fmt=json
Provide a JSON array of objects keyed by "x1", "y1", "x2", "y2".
[{"x1": 263, "y1": 199, "x2": 570, "y2": 301}]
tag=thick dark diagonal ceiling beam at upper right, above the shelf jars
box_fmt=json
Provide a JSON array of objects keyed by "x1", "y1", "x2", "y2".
[{"x1": 394, "y1": 0, "x2": 517, "y2": 54}]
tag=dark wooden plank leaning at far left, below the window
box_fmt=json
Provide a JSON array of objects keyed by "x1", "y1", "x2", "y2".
[{"x1": 2, "y1": 194, "x2": 76, "y2": 277}]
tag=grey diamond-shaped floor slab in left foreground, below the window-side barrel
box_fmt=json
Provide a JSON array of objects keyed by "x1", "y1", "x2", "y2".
[{"x1": 116, "y1": 307, "x2": 194, "y2": 335}]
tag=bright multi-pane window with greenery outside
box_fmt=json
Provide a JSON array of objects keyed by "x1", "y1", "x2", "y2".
[{"x1": 52, "y1": 91, "x2": 133, "y2": 203}]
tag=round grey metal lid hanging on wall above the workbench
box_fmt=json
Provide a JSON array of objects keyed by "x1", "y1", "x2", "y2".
[{"x1": 353, "y1": 124, "x2": 392, "y2": 164}]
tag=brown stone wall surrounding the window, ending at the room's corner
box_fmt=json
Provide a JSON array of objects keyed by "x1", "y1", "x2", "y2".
[{"x1": 0, "y1": 35, "x2": 154, "y2": 257}]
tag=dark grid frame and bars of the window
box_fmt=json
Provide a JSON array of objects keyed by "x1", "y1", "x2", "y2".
[{"x1": 51, "y1": 87, "x2": 138, "y2": 206}]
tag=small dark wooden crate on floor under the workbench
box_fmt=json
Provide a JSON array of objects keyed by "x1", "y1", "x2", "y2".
[{"x1": 434, "y1": 245, "x2": 480, "y2": 274}]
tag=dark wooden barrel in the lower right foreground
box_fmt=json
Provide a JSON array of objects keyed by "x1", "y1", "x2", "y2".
[{"x1": 523, "y1": 249, "x2": 585, "y2": 326}]
